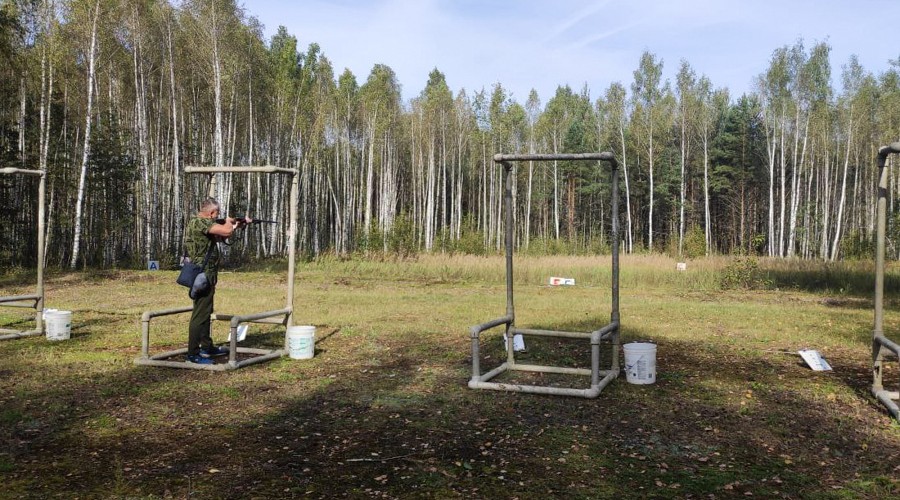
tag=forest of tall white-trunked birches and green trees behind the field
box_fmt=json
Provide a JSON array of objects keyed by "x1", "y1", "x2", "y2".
[{"x1": 0, "y1": 0, "x2": 900, "y2": 267}]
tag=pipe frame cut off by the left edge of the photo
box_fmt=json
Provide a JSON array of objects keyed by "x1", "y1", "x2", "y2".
[{"x1": 0, "y1": 167, "x2": 47, "y2": 340}]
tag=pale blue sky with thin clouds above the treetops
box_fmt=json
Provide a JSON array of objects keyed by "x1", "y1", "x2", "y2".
[{"x1": 239, "y1": 0, "x2": 900, "y2": 103}]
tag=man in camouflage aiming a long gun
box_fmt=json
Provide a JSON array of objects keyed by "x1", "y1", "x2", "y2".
[{"x1": 184, "y1": 198, "x2": 248, "y2": 365}]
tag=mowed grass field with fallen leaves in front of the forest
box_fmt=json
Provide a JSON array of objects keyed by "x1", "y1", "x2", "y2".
[{"x1": 0, "y1": 256, "x2": 900, "y2": 498}]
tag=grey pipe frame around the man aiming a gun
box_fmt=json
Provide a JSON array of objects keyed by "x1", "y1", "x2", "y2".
[{"x1": 134, "y1": 166, "x2": 300, "y2": 371}]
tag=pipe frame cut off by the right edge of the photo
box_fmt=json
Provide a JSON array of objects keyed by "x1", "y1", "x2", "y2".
[{"x1": 872, "y1": 142, "x2": 900, "y2": 420}]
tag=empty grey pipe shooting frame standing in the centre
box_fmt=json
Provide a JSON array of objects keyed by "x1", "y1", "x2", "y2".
[{"x1": 469, "y1": 152, "x2": 620, "y2": 398}]
